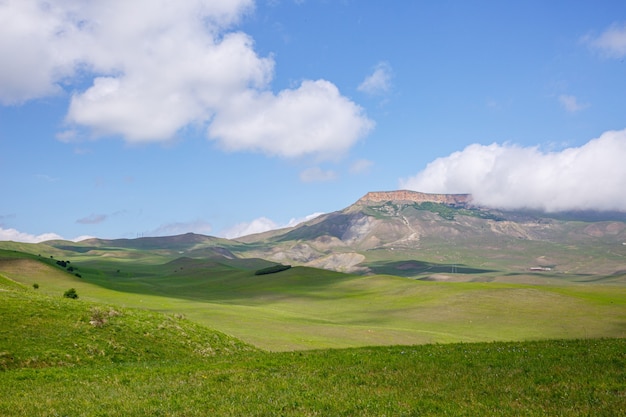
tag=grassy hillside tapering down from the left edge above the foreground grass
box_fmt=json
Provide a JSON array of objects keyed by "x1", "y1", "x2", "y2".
[{"x1": 0, "y1": 276, "x2": 253, "y2": 370}]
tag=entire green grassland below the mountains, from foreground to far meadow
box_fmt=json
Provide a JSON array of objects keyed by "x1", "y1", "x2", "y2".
[{"x1": 0, "y1": 246, "x2": 626, "y2": 416}]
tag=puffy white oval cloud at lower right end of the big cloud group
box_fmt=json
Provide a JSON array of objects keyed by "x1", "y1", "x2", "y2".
[{"x1": 209, "y1": 80, "x2": 373, "y2": 158}]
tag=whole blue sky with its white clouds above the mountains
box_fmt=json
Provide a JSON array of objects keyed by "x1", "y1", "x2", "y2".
[{"x1": 0, "y1": 0, "x2": 626, "y2": 242}]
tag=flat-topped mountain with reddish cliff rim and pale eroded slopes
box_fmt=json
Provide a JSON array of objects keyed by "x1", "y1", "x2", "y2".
[{"x1": 238, "y1": 190, "x2": 626, "y2": 276}]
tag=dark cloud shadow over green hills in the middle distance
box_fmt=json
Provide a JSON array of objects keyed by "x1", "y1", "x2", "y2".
[{"x1": 69, "y1": 258, "x2": 361, "y2": 304}]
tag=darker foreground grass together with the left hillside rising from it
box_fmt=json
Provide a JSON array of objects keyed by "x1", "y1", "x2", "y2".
[{"x1": 0, "y1": 278, "x2": 626, "y2": 417}]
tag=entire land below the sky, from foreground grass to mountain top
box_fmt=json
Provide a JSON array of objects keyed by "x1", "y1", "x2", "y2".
[{"x1": 0, "y1": 193, "x2": 626, "y2": 415}]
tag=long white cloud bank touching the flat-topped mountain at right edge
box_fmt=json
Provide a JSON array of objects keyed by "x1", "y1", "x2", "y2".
[{"x1": 400, "y1": 130, "x2": 626, "y2": 211}]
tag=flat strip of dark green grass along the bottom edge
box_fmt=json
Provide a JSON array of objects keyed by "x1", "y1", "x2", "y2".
[{"x1": 0, "y1": 340, "x2": 626, "y2": 416}]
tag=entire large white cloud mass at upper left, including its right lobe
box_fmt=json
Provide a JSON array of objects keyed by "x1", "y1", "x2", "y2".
[{"x1": 0, "y1": 0, "x2": 373, "y2": 157}]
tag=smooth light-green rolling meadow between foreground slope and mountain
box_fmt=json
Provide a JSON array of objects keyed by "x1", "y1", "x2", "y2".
[{"x1": 0, "y1": 253, "x2": 626, "y2": 351}]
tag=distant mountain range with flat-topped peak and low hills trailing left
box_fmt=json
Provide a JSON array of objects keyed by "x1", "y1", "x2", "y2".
[{"x1": 22, "y1": 190, "x2": 626, "y2": 281}]
